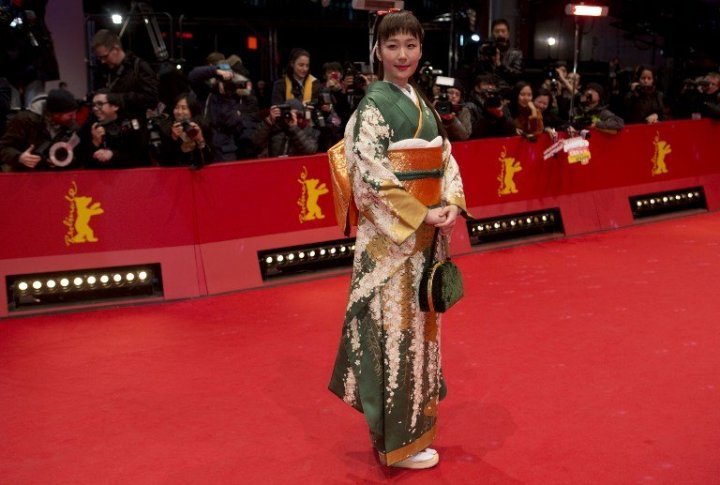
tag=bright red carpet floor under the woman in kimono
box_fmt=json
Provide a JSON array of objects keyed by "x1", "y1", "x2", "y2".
[{"x1": 0, "y1": 214, "x2": 720, "y2": 485}]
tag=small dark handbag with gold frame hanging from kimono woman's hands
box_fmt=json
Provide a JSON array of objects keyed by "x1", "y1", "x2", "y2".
[{"x1": 418, "y1": 229, "x2": 464, "y2": 313}]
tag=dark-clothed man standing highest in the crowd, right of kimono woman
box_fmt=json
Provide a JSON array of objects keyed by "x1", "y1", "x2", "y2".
[{"x1": 478, "y1": 19, "x2": 523, "y2": 87}]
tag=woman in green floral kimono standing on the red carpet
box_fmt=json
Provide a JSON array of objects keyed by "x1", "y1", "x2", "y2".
[{"x1": 329, "y1": 11, "x2": 466, "y2": 468}]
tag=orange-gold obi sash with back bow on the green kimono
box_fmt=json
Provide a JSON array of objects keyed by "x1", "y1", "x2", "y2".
[{"x1": 328, "y1": 141, "x2": 443, "y2": 236}]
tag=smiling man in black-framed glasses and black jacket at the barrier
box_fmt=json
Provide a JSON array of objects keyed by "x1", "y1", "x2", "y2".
[{"x1": 83, "y1": 89, "x2": 150, "y2": 169}]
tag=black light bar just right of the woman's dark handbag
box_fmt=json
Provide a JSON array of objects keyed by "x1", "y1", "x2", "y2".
[{"x1": 467, "y1": 209, "x2": 564, "y2": 246}]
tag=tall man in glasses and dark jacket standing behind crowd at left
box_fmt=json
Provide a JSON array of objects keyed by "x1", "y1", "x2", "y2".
[{"x1": 91, "y1": 29, "x2": 159, "y2": 122}]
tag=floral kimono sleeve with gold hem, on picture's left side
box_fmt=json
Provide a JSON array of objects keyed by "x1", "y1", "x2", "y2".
[{"x1": 345, "y1": 100, "x2": 428, "y2": 245}]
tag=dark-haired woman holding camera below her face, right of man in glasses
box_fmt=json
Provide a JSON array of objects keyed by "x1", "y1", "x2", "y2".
[{"x1": 158, "y1": 93, "x2": 212, "y2": 168}]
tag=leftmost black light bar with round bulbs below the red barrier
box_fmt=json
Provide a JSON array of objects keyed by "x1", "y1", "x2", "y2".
[{"x1": 5, "y1": 263, "x2": 163, "y2": 312}]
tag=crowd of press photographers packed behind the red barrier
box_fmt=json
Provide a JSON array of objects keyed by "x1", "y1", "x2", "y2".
[{"x1": 0, "y1": 19, "x2": 720, "y2": 171}]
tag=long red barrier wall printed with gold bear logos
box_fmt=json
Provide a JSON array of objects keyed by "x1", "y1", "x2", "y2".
[{"x1": 0, "y1": 120, "x2": 720, "y2": 316}]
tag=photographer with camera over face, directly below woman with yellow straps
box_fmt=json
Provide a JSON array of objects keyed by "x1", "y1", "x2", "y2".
[{"x1": 253, "y1": 99, "x2": 320, "y2": 157}]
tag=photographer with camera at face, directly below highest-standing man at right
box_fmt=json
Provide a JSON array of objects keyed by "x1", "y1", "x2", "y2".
[{"x1": 467, "y1": 74, "x2": 515, "y2": 138}]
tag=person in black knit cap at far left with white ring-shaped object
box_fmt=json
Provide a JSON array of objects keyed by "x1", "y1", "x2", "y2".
[{"x1": 0, "y1": 89, "x2": 81, "y2": 172}]
